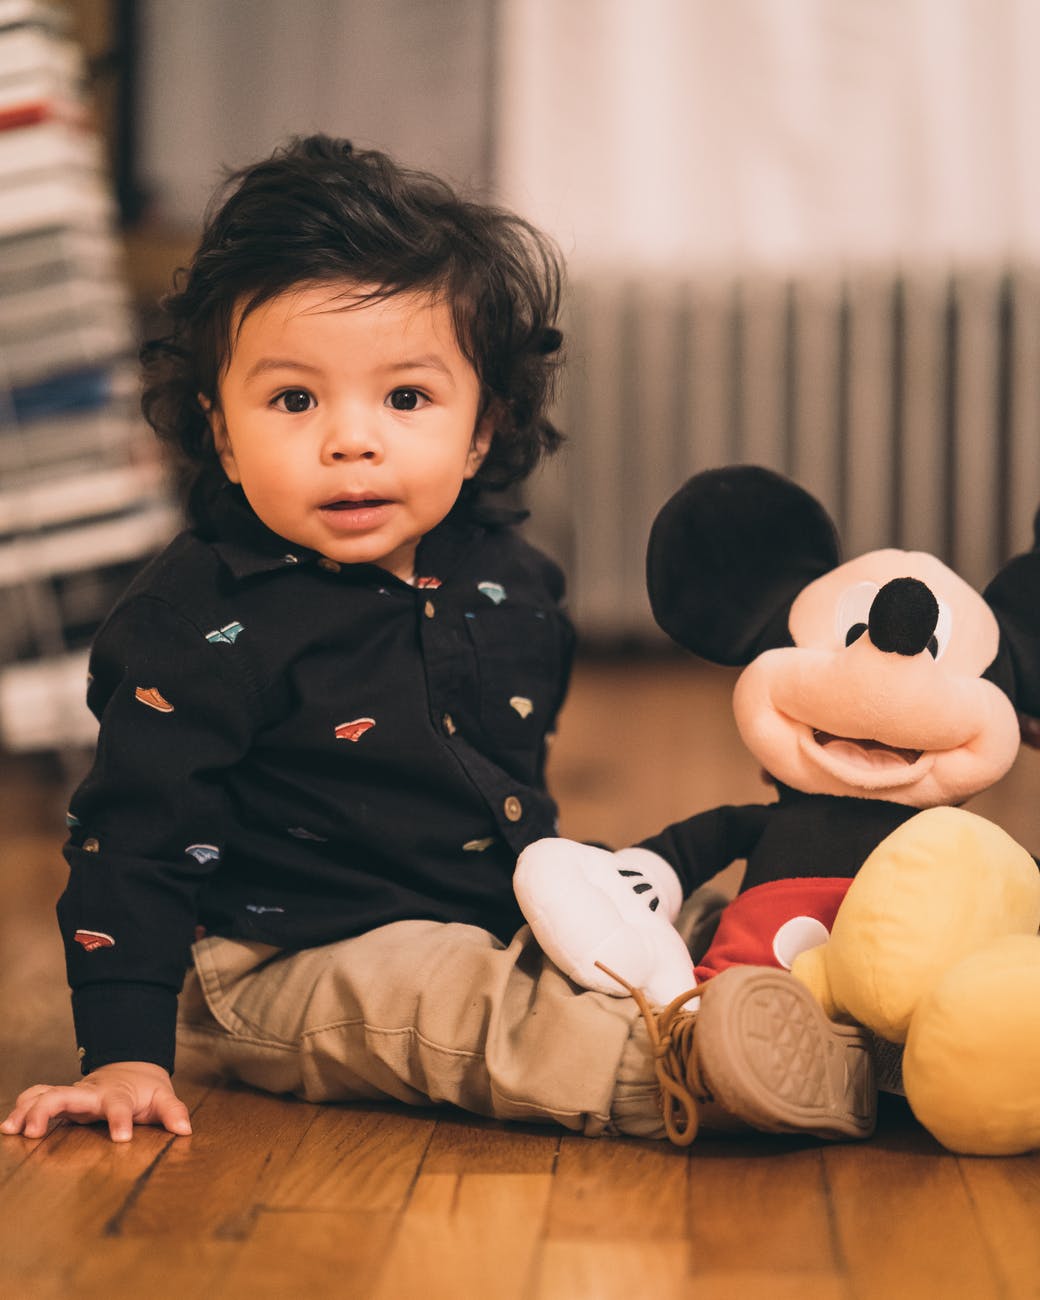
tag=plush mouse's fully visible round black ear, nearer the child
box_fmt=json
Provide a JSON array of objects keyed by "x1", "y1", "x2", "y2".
[{"x1": 646, "y1": 465, "x2": 840, "y2": 664}]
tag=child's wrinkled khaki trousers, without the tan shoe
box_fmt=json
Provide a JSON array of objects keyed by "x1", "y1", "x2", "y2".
[{"x1": 178, "y1": 920, "x2": 650, "y2": 1135}]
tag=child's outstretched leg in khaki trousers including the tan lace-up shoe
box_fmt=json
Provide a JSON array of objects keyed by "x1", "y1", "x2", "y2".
[{"x1": 178, "y1": 920, "x2": 874, "y2": 1143}]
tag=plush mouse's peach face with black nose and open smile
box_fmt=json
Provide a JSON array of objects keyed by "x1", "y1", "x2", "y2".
[{"x1": 733, "y1": 550, "x2": 1019, "y2": 809}]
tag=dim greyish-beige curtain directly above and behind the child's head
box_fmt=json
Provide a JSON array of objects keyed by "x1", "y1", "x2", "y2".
[{"x1": 137, "y1": 0, "x2": 495, "y2": 230}]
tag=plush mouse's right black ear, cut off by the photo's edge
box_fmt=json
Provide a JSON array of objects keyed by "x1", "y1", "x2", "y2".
[{"x1": 983, "y1": 543, "x2": 1040, "y2": 718}]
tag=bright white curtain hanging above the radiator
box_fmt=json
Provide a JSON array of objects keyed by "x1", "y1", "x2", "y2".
[{"x1": 497, "y1": 0, "x2": 1040, "y2": 270}]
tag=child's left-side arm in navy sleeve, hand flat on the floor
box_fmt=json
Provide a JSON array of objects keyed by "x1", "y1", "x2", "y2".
[{"x1": 51, "y1": 595, "x2": 255, "y2": 1136}]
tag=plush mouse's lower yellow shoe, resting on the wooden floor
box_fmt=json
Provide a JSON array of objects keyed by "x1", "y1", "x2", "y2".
[{"x1": 902, "y1": 935, "x2": 1040, "y2": 1156}]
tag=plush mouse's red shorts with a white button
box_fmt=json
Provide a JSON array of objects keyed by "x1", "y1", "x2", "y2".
[{"x1": 696, "y1": 876, "x2": 852, "y2": 980}]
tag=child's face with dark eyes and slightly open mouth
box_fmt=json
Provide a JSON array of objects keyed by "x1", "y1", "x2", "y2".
[{"x1": 209, "y1": 283, "x2": 491, "y2": 581}]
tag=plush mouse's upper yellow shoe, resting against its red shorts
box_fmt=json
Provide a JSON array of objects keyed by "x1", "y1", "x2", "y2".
[{"x1": 792, "y1": 807, "x2": 1040, "y2": 1043}]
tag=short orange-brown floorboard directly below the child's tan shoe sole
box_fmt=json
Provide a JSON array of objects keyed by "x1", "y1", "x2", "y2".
[{"x1": 546, "y1": 1135, "x2": 690, "y2": 1242}]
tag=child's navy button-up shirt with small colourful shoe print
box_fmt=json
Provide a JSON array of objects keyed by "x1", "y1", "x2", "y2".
[{"x1": 59, "y1": 484, "x2": 573, "y2": 1073}]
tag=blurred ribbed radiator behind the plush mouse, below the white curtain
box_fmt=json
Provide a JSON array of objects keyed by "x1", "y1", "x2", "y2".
[{"x1": 528, "y1": 268, "x2": 1040, "y2": 642}]
